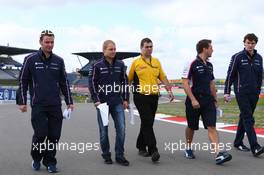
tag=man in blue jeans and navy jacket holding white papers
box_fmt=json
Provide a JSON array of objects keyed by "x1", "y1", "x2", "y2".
[{"x1": 89, "y1": 40, "x2": 129, "y2": 166}]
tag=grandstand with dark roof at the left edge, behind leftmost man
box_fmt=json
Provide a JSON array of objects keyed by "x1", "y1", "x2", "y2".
[{"x1": 0, "y1": 46, "x2": 37, "y2": 86}]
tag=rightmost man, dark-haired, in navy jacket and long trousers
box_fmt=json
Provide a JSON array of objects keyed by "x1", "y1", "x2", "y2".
[{"x1": 224, "y1": 33, "x2": 264, "y2": 156}]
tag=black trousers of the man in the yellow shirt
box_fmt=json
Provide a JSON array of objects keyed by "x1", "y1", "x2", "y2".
[{"x1": 134, "y1": 94, "x2": 159, "y2": 154}]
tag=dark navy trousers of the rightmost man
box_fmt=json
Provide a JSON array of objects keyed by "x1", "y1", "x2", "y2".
[{"x1": 234, "y1": 94, "x2": 259, "y2": 152}]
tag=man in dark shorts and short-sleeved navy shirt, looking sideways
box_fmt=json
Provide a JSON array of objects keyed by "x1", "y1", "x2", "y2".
[{"x1": 182, "y1": 39, "x2": 232, "y2": 165}]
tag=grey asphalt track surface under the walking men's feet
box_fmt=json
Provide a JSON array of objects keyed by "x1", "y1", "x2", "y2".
[{"x1": 0, "y1": 104, "x2": 264, "y2": 175}]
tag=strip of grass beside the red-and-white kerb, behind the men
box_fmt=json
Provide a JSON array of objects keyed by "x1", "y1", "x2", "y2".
[{"x1": 157, "y1": 98, "x2": 264, "y2": 128}]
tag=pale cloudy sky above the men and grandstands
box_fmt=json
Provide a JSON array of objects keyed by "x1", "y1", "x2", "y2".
[{"x1": 0, "y1": 0, "x2": 264, "y2": 79}]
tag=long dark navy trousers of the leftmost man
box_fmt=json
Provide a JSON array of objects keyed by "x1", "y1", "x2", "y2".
[{"x1": 31, "y1": 106, "x2": 63, "y2": 166}]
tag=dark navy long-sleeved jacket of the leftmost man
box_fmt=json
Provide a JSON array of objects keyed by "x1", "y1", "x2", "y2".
[{"x1": 17, "y1": 49, "x2": 73, "y2": 106}]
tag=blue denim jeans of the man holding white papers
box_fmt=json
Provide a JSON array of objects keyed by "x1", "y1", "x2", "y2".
[{"x1": 97, "y1": 104, "x2": 125, "y2": 159}]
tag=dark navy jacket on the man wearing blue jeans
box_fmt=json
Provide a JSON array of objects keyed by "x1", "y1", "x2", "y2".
[{"x1": 89, "y1": 58, "x2": 129, "y2": 105}]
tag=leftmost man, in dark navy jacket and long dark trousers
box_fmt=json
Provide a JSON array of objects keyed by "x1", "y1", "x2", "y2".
[{"x1": 17, "y1": 30, "x2": 73, "y2": 173}]
